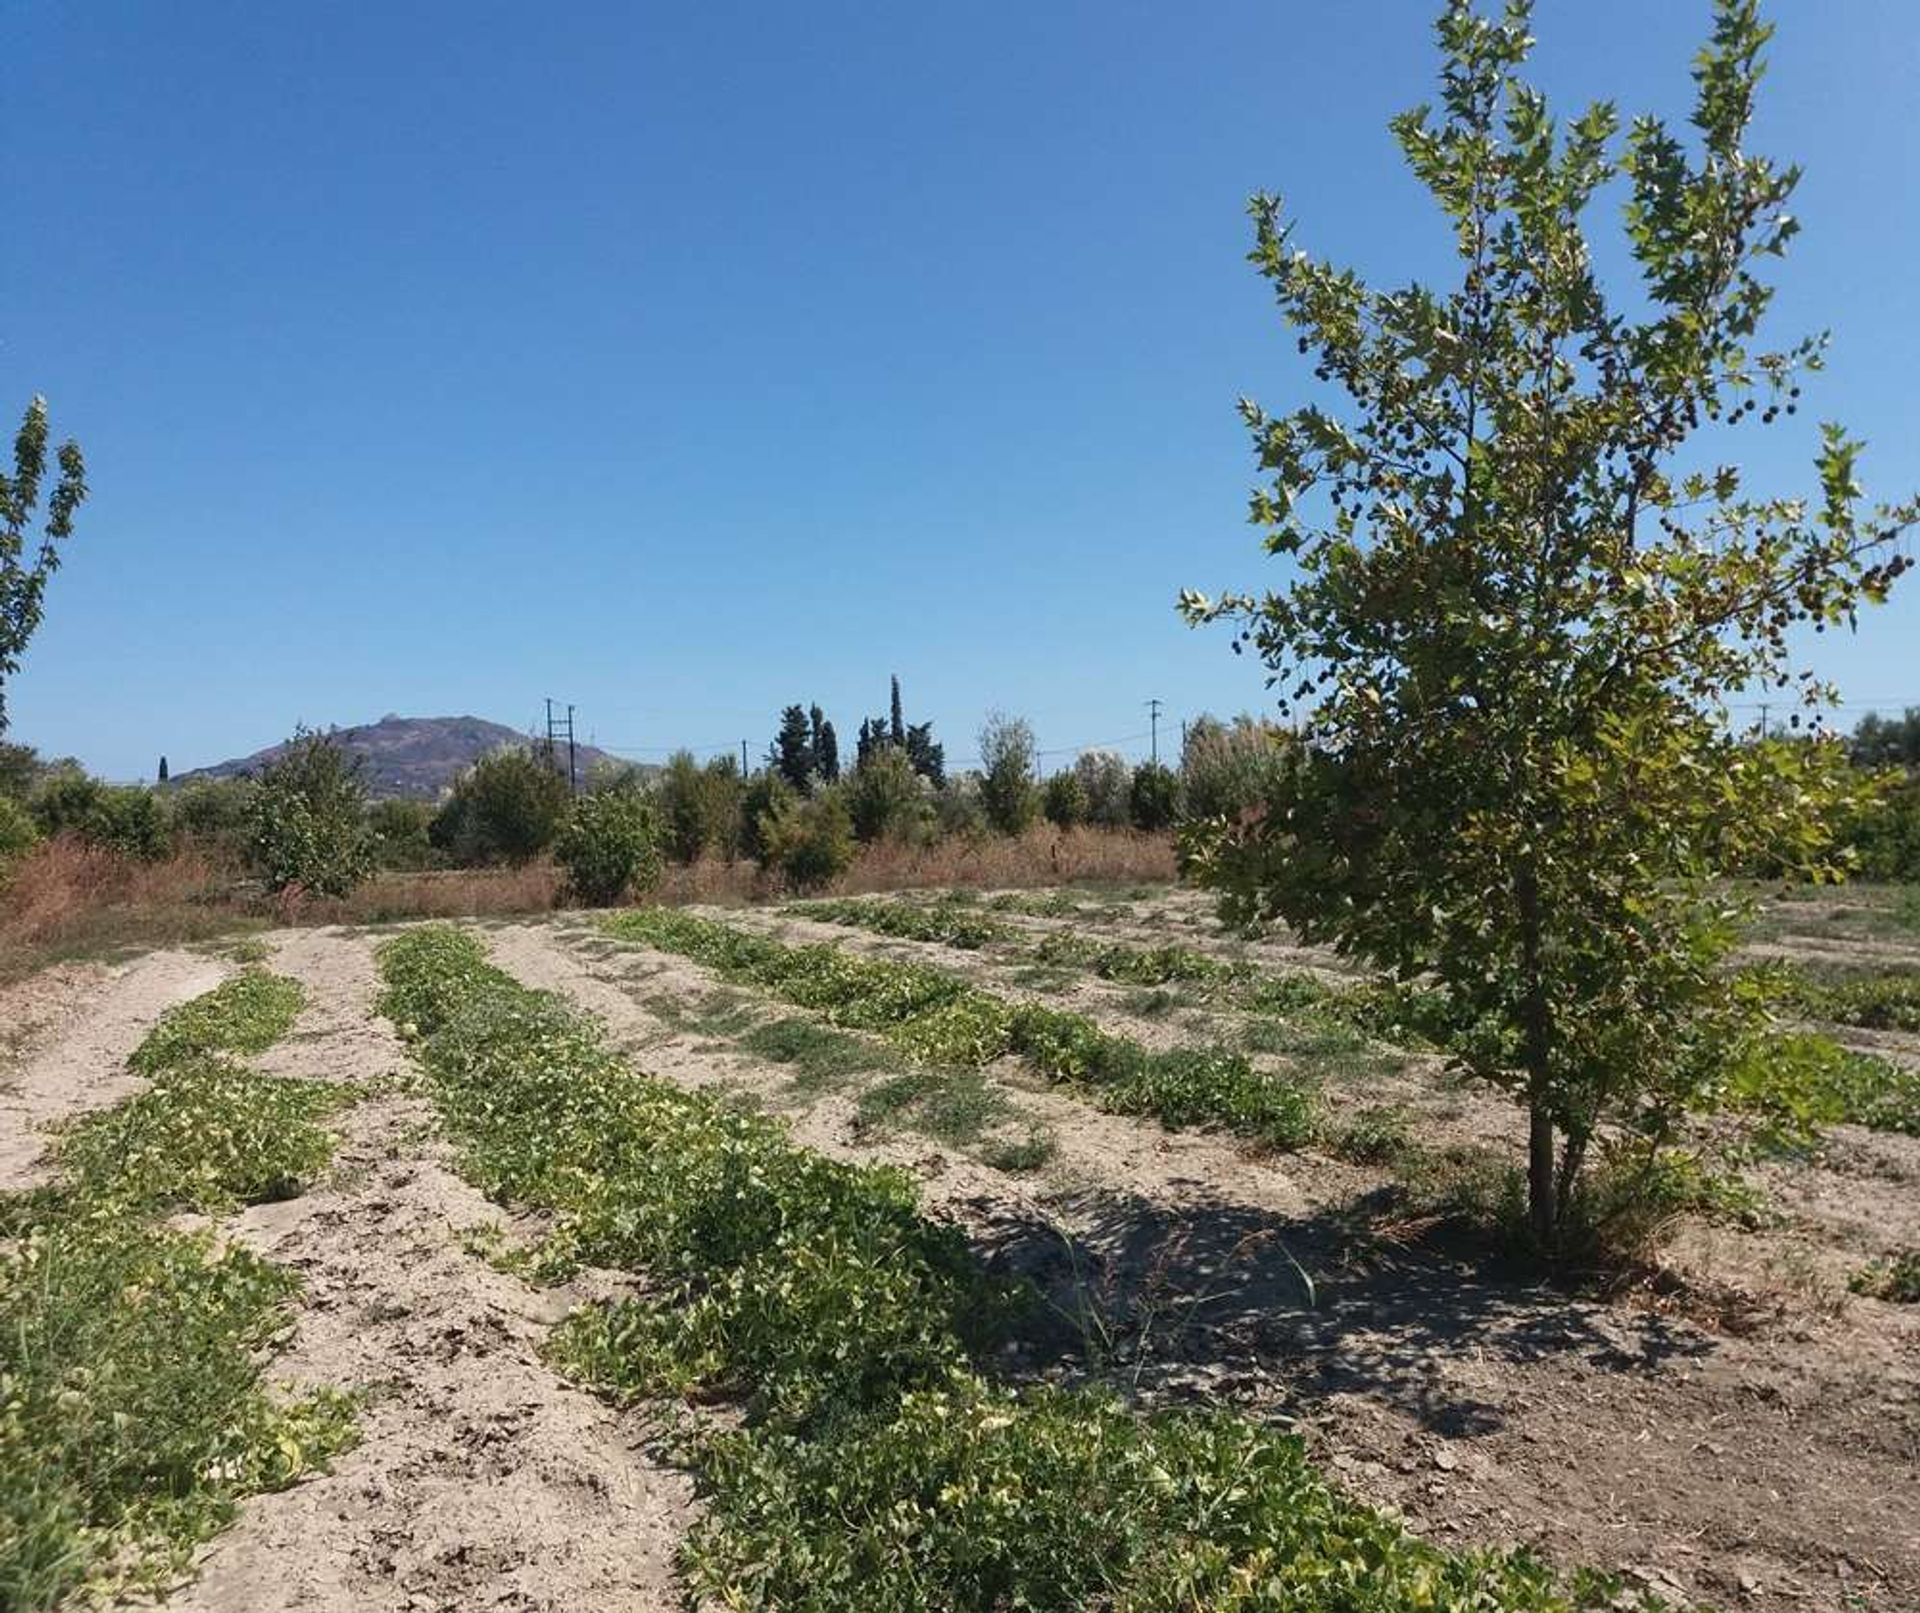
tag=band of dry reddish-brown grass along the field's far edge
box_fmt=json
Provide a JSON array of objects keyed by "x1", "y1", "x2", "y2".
[{"x1": 0, "y1": 828, "x2": 1175, "y2": 979}]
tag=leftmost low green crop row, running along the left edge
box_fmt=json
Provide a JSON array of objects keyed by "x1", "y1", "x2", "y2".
[{"x1": 0, "y1": 974, "x2": 353, "y2": 1609}]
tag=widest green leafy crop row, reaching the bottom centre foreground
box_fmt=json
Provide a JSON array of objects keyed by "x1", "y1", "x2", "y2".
[{"x1": 380, "y1": 927, "x2": 1666, "y2": 1613}]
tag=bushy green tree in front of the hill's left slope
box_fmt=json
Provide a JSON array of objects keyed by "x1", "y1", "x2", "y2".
[{"x1": 248, "y1": 728, "x2": 372, "y2": 897}]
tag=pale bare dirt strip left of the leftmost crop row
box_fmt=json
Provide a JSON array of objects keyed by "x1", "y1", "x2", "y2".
[{"x1": 0, "y1": 952, "x2": 232, "y2": 1187}]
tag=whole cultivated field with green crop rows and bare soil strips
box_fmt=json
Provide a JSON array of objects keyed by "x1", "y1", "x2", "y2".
[{"x1": 0, "y1": 887, "x2": 1920, "y2": 1613}]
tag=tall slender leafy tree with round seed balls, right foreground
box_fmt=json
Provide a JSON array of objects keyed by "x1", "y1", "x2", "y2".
[{"x1": 1183, "y1": 0, "x2": 1916, "y2": 1250}]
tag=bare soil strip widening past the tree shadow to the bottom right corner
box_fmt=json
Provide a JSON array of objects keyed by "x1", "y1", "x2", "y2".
[{"x1": 506, "y1": 926, "x2": 1920, "y2": 1613}]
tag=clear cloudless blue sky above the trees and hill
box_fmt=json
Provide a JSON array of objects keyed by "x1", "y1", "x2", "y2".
[{"x1": 0, "y1": 0, "x2": 1920, "y2": 776}]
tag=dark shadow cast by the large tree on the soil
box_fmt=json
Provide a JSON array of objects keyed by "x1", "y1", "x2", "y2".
[{"x1": 972, "y1": 1192, "x2": 1713, "y2": 1438}]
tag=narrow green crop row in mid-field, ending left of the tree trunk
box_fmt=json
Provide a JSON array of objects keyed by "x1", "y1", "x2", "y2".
[{"x1": 607, "y1": 908, "x2": 1313, "y2": 1148}]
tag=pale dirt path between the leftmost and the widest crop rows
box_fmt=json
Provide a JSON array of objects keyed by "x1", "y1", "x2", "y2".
[{"x1": 169, "y1": 931, "x2": 689, "y2": 1613}]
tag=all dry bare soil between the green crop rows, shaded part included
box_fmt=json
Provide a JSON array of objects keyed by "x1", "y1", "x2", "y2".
[{"x1": 0, "y1": 895, "x2": 1920, "y2": 1613}]
